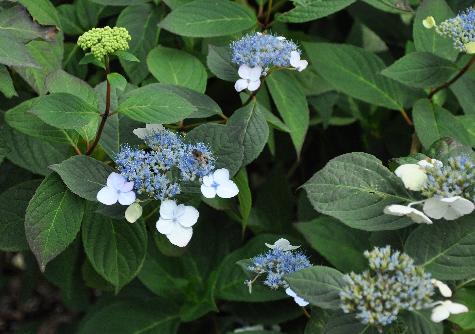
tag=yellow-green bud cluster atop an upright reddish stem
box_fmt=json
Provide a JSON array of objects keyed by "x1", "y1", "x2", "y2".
[{"x1": 78, "y1": 26, "x2": 132, "y2": 60}]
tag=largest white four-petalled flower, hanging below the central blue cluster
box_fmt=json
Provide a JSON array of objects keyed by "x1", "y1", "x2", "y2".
[{"x1": 156, "y1": 200, "x2": 200, "y2": 247}]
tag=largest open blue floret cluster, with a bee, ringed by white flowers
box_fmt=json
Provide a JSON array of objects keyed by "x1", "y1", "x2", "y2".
[{"x1": 115, "y1": 130, "x2": 215, "y2": 200}]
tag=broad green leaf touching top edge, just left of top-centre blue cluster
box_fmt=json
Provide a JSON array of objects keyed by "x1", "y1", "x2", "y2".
[{"x1": 160, "y1": 0, "x2": 257, "y2": 37}]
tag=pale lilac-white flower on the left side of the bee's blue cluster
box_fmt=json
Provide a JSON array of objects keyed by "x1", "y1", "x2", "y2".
[{"x1": 96, "y1": 173, "x2": 135, "y2": 205}]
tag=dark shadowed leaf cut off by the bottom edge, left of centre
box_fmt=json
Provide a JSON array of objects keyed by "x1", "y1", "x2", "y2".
[{"x1": 77, "y1": 298, "x2": 179, "y2": 334}]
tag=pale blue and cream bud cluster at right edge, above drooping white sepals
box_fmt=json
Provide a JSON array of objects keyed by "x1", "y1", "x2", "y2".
[{"x1": 422, "y1": 155, "x2": 475, "y2": 202}]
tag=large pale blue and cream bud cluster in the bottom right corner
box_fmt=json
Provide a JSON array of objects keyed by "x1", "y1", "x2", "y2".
[{"x1": 340, "y1": 246, "x2": 434, "y2": 327}]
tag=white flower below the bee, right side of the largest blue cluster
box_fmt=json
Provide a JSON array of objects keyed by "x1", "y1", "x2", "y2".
[{"x1": 201, "y1": 168, "x2": 239, "y2": 198}]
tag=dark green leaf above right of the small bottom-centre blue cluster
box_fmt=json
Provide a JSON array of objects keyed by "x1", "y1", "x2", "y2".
[{"x1": 295, "y1": 217, "x2": 371, "y2": 272}]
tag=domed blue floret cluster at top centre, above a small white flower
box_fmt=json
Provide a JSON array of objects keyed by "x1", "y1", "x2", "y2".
[{"x1": 231, "y1": 33, "x2": 300, "y2": 72}]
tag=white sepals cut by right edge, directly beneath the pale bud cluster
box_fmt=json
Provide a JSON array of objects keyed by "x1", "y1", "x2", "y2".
[{"x1": 423, "y1": 196, "x2": 475, "y2": 220}]
